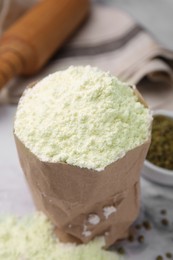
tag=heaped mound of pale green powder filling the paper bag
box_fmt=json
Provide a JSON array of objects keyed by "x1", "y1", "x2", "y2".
[{"x1": 14, "y1": 66, "x2": 151, "y2": 171}]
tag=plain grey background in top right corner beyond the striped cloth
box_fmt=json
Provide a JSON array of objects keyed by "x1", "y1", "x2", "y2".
[{"x1": 93, "y1": 0, "x2": 173, "y2": 50}]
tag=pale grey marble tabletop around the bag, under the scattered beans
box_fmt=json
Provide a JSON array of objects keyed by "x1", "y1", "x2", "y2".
[{"x1": 0, "y1": 105, "x2": 173, "y2": 260}]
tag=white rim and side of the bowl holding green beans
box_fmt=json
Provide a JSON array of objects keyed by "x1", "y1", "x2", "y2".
[{"x1": 142, "y1": 110, "x2": 173, "y2": 186}]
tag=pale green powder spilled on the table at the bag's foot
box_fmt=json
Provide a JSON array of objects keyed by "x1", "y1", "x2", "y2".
[{"x1": 0, "y1": 213, "x2": 122, "y2": 260}]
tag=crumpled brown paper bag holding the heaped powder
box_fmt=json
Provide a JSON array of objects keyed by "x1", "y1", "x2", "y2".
[{"x1": 15, "y1": 84, "x2": 150, "y2": 247}]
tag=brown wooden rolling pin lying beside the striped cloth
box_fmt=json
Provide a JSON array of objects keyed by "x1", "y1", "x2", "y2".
[{"x1": 0, "y1": 0, "x2": 89, "y2": 89}]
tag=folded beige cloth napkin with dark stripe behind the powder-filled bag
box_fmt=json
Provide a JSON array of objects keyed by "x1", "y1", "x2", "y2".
[{"x1": 0, "y1": 0, "x2": 173, "y2": 107}]
